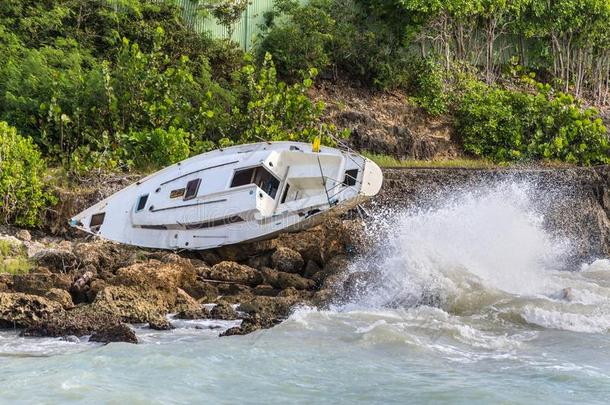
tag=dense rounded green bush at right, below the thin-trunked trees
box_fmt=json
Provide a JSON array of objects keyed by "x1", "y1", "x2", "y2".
[{"x1": 455, "y1": 78, "x2": 610, "y2": 165}]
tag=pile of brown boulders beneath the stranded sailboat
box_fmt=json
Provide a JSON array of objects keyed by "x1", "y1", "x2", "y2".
[{"x1": 0, "y1": 215, "x2": 360, "y2": 343}]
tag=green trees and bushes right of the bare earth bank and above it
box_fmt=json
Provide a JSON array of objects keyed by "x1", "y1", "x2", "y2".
[{"x1": 260, "y1": 0, "x2": 610, "y2": 165}]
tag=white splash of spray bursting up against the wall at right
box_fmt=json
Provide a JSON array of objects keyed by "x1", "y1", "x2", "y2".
[{"x1": 333, "y1": 182, "x2": 610, "y2": 332}]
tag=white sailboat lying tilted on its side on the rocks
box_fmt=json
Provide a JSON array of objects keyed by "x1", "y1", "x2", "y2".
[{"x1": 70, "y1": 142, "x2": 383, "y2": 250}]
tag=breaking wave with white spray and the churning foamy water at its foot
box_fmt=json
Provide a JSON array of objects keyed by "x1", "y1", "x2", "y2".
[{"x1": 291, "y1": 181, "x2": 610, "y2": 361}]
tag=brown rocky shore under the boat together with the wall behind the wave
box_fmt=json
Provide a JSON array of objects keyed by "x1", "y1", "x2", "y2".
[{"x1": 0, "y1": 167, "x2": 610, "y2": 343}]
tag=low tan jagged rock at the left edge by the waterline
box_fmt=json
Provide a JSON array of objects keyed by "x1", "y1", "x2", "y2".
[{"x1": 0, "y1": 293, "x2": 64, "y2": 328}]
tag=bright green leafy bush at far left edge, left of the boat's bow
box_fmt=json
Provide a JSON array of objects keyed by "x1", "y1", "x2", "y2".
[{"x1": 0, "y1": 121, "x2": 54, "y2": 226}]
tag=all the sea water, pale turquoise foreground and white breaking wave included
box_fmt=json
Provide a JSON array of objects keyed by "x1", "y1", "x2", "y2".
[{"x1": 0, "y1": 182, "x2": 610, "y2": 404}]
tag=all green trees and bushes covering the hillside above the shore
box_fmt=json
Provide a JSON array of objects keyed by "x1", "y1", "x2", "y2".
[{"x1": 0, "y1": 0, "x2": 610, "y2": 226}]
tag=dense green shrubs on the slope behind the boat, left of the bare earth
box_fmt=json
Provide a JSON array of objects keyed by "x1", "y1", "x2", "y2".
[{"x1": 0, "y1": 0, "x2": 340, "y2": 172}]
